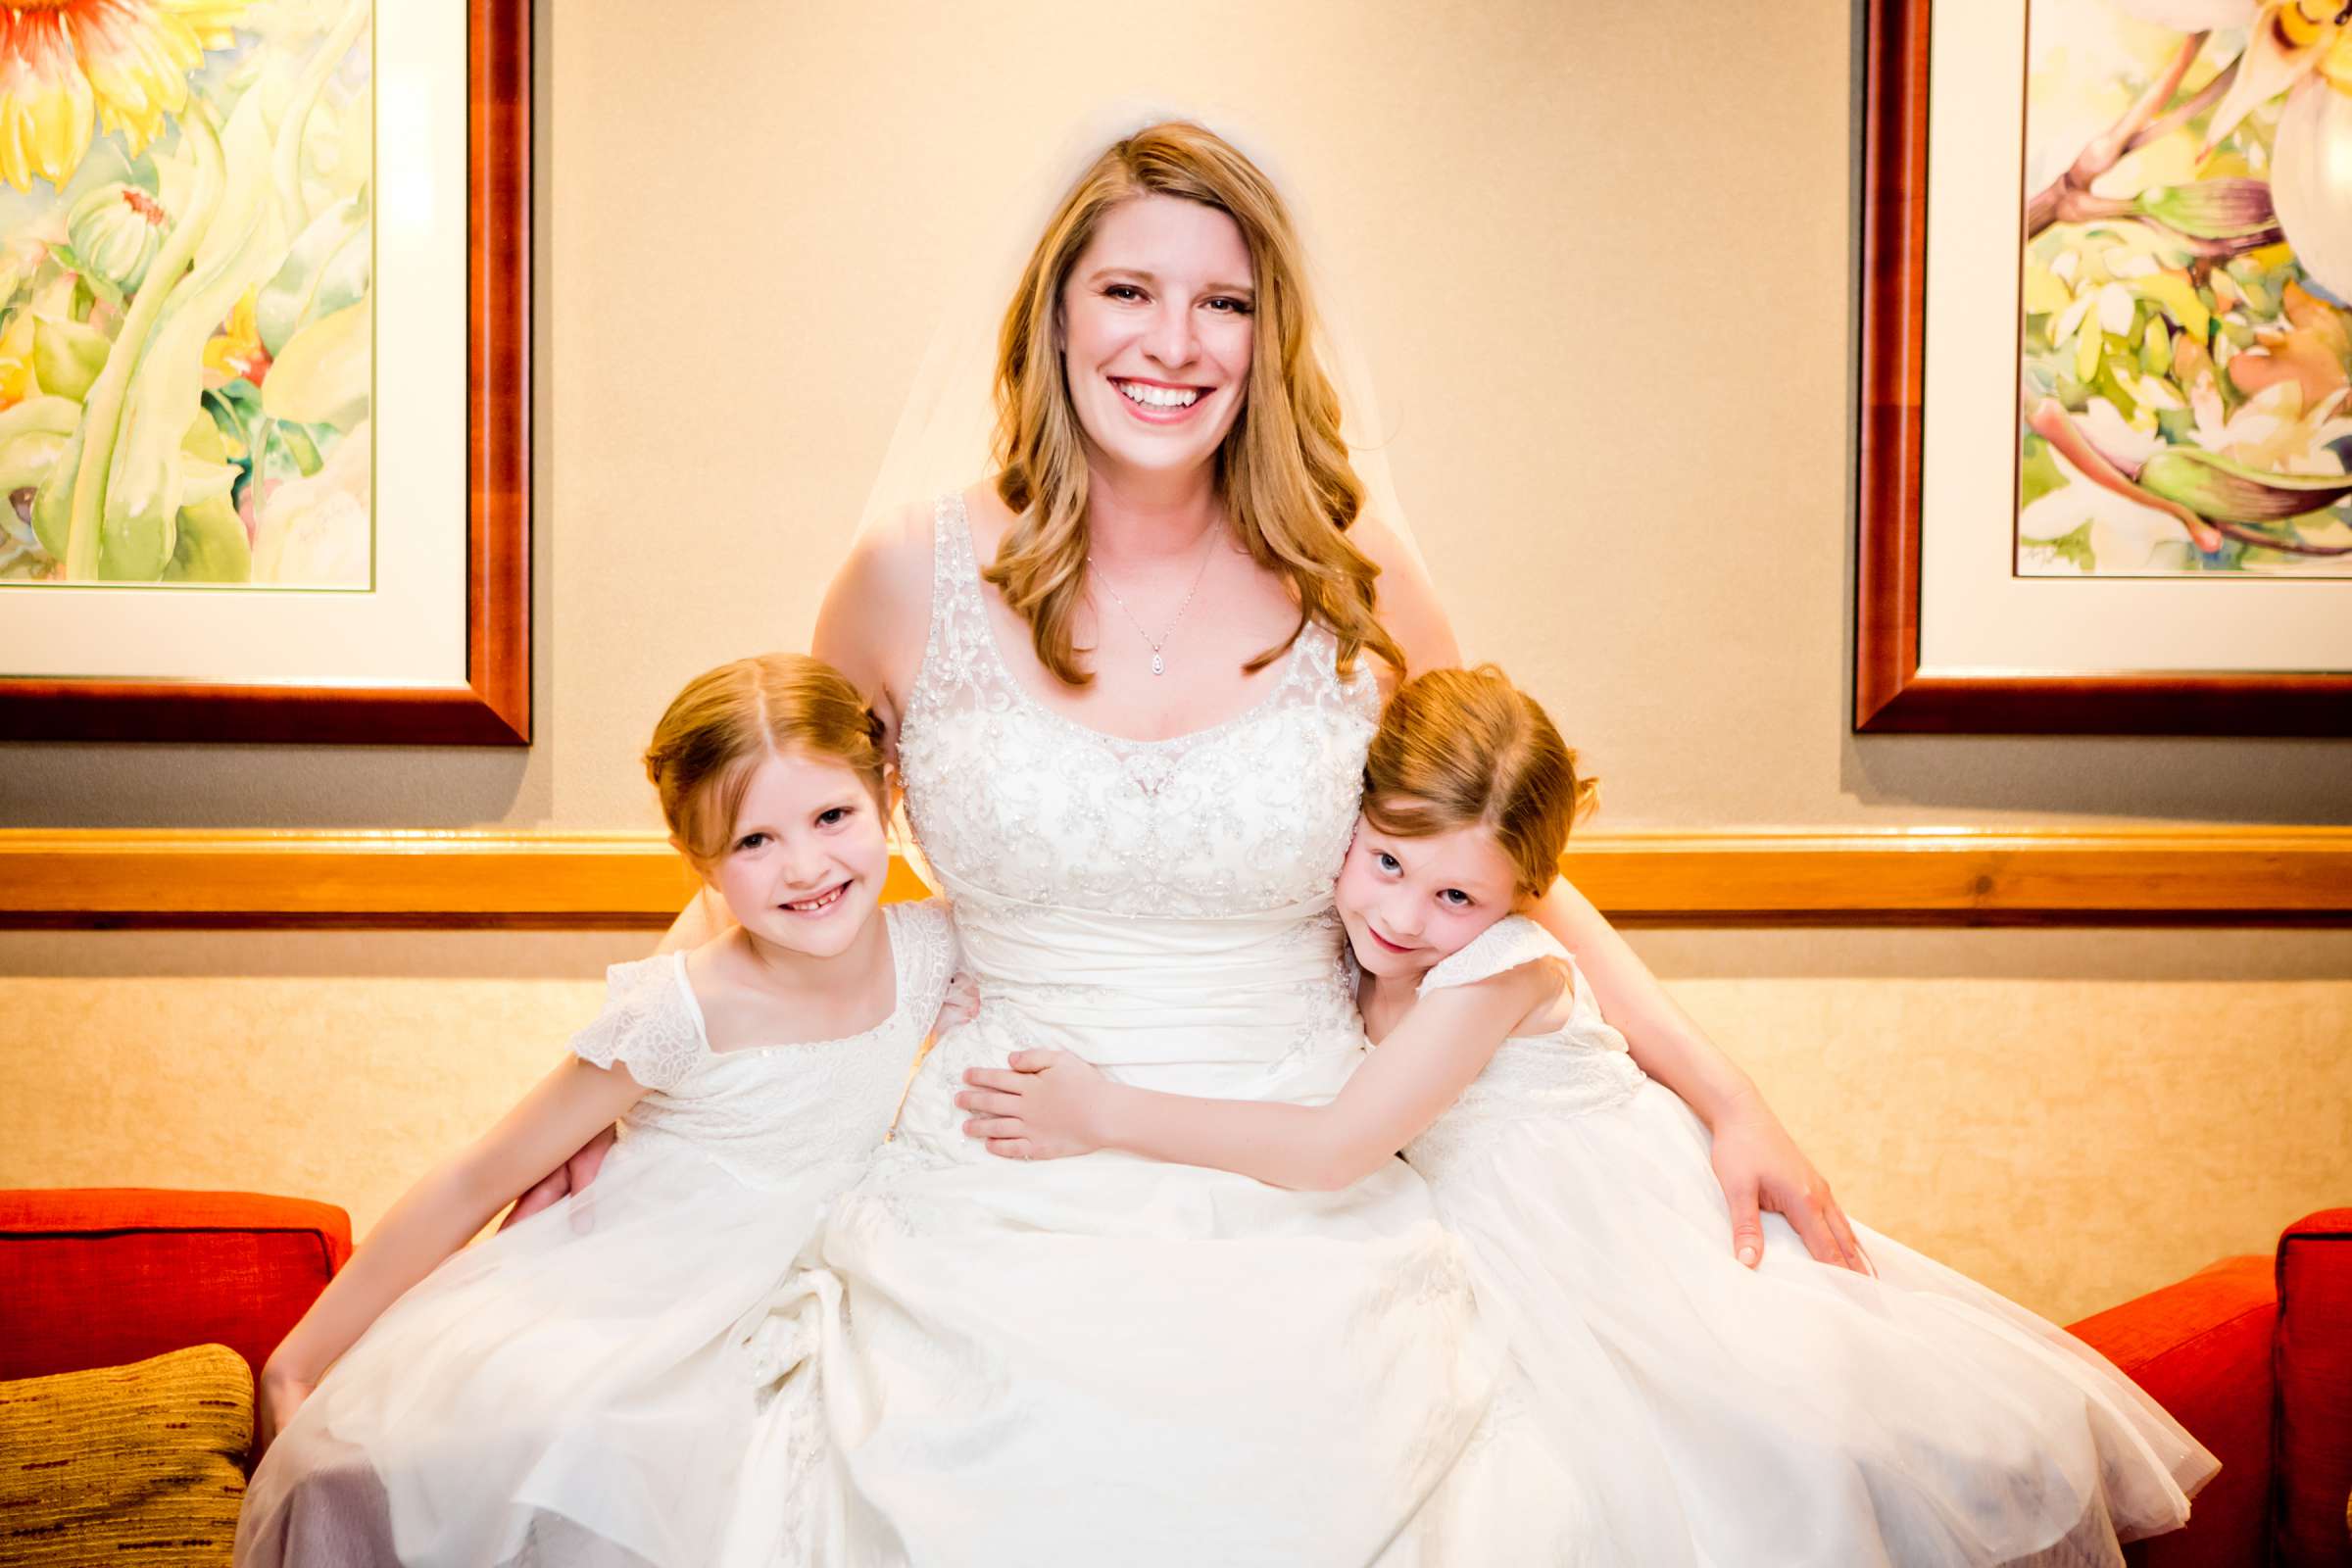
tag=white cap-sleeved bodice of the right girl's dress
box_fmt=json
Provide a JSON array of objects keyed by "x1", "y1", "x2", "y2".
[{"x1": 1404, "y1": 914, "x2": 1646, "y2": 1183}]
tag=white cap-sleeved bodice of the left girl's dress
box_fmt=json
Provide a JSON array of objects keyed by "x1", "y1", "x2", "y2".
[{"x1": 571, "y1": 903, "x2": 955, "y2": 1187}]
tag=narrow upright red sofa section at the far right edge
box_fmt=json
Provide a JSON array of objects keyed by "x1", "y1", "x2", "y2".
[{"x1": 2277, "y1": 1208, "x2": 2352, "y2": 1568}]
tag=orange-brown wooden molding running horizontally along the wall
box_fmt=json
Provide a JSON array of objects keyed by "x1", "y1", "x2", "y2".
[{"x1": 0, "y1": 827, "x2": 2352, "y2": 929}]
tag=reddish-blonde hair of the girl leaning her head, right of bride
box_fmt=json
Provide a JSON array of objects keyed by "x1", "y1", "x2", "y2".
[{"x1": 1364, "y1": 665, "x2": 1599, "y2": 898}]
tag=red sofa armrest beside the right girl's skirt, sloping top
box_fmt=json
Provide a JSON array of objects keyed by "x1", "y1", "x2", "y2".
[{"x1": 2072, "y1": 1257, "x2": 2279, "y2": 1568}]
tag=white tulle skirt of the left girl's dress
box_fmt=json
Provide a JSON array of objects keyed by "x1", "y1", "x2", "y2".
[{"x1": 237, "y1": 1136, "x2": 852, "y2": 1568}]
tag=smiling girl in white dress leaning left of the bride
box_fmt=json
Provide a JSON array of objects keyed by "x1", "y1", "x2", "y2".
[{"x1": 237, "y1": 654, "x2": 953, "y2": 1568}]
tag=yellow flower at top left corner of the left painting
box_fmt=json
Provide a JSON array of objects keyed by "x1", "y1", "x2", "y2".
[{"x1": 0, "y1": 0, "x2": 249, "y2": 190}]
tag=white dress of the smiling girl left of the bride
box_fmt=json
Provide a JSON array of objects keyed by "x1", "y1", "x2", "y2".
[{"x1": 237, "y1": 903, "x2": 955, "y2": 1568}]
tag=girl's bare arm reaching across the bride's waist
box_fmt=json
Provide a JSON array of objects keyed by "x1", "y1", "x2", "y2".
[{"x1": 955, "y1": 961, "x2": 1562, "y2": 1192}]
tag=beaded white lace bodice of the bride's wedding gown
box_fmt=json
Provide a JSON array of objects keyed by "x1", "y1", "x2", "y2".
[{"x1": 899, "y1": 496, "x2": 1378, "y2": 1109}]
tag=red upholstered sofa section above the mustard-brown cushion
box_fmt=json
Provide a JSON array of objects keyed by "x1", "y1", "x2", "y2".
[{"x1": 0, "y1": 1187, "x2": 351, "y2": 1380}]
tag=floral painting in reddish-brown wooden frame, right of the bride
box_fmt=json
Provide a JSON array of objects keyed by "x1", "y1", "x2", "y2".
[{"x1": 1853, "y1": 0, "x2": 2352, "y2": 736}]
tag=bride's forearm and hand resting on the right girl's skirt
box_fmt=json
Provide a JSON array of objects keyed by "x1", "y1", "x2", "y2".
[{"x1": 1534, "y1": 877, "x2": 1870, "y2": 1274}]
